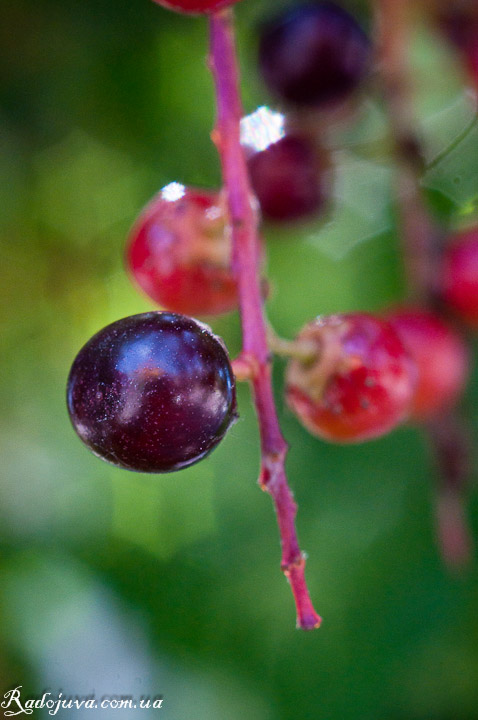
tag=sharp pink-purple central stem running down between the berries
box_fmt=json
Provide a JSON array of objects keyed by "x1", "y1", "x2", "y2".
[{"x1": 209, "y1": 9, "x2": 321, "y2": 630}]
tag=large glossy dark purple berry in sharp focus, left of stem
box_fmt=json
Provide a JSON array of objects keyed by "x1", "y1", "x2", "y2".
[{"x1": 67, "y1": 312, "x2": 236, "y2": 473}]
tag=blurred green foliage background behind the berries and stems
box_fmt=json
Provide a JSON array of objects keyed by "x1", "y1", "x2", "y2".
[{"x1": 0, "y1": 0, "x2": 478, "y2": 720}]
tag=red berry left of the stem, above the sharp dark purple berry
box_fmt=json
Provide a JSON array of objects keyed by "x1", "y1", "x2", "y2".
[{"x1": 126, "y1": 188, "x2": 238, "y2": 315}]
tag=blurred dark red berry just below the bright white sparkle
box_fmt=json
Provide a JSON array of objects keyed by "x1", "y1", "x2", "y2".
[{"x1": 248, "y1": 135, "x2": 328, "y2": 222}]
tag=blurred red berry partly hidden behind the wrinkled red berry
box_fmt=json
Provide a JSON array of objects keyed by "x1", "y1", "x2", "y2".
[{"x1": 387, "y1": 308, "x2": 468, "y2": 420}]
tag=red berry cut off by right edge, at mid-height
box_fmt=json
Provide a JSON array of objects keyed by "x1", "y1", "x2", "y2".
[{"x1": 440, "y1": 228, "x2": 478, "y2": 328}]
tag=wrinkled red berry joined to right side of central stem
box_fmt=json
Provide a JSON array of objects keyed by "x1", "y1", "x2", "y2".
[{"x1": 286, "y1": 313, "x2": 416, "y2": 443}]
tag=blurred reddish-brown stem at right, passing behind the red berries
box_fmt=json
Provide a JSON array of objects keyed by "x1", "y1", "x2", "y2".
[{"x1": 375, "y1": 0, "x2": 471, "y2": 567}]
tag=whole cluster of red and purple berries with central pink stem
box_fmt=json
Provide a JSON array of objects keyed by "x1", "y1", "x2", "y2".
[{"x1": 68, "y1": 0, "x2": 478, "y2": 629}]
